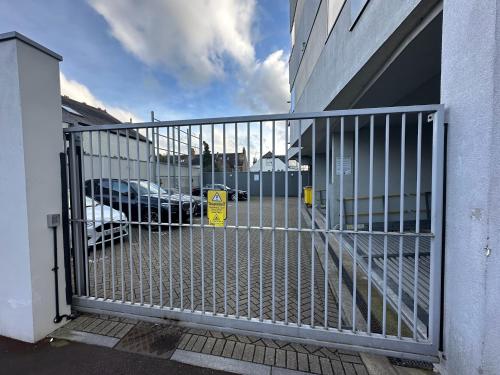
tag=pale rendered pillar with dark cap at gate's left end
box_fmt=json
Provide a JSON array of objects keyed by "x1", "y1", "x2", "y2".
[{"x1": 0, "y1": 33, "x2": 69, "y2": 342}]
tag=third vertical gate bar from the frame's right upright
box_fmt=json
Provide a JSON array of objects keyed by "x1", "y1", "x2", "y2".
[{"x1": 382, "y1": 114, "x2": 390, "y2": 336}]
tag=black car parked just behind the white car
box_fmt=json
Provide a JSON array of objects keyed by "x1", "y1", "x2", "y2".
[{"x1": 85, "y1": 178, "x2": 196, "y2": 223}]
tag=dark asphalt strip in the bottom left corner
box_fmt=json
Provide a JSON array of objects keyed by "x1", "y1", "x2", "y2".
[{"x1": 0, "y1": 336, "x2": 229, "y2": 375}]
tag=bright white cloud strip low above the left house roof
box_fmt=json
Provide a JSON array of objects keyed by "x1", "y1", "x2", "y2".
[{"x1": 60, "y1": 72, "x2": 142, "y2": 122}]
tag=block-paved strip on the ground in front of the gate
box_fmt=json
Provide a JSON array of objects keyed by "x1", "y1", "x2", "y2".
[{"x1": 51, "y1": 314, "x2": 367, "y2": 375}]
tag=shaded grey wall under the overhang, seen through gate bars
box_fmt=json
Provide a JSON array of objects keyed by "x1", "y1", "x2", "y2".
[{"x1": 315, "y1": 116, "x2": 432, "y2": 226}]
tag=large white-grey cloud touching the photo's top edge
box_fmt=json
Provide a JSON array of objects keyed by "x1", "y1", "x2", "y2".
[{"x1": 89, "y1": 0, "x2": 255, "y2": 84}]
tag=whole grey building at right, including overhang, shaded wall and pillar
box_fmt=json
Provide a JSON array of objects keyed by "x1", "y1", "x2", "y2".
[{"x1": 289, "y1": 0, "x2": 500, "y2": 374}]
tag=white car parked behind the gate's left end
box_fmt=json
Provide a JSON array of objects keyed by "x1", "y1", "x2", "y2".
[{"x1": 85, "y1": 197, "x2": 128, "y2": 247}]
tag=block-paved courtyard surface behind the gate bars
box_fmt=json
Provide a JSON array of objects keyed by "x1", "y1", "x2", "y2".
[{"x1": 88, "y1": 198, "x2": 342, "y2": 328}]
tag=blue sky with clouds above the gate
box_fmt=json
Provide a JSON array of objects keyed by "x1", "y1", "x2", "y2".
[{"x1": 0, "y1": 0, "x2": 290, "y2": 121}]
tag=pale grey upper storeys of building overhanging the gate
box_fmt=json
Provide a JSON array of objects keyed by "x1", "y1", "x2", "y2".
[{"x1": 290, "y1": 0, "x2": 439, "y2": 143}]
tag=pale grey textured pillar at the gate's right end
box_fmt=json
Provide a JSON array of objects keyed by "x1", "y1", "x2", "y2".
[{"x1": 441, "y1": 0, "x2": 500, "y2": 374}]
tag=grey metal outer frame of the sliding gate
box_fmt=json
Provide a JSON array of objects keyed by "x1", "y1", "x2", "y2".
[{"x1": 63, "y1": 104, "x2": 445, "y2": 362}]
